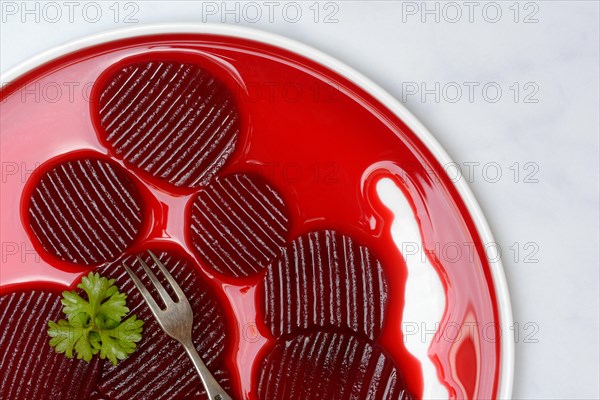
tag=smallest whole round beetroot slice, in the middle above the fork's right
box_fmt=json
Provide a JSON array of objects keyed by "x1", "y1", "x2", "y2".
[{"x1": 188, "y1": 174, "x2": 288, "y2": 277}]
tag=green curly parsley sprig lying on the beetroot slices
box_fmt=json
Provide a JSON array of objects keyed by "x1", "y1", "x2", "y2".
[{"x1": 48, "y1": 272, "x2": 144, "y2": 365}]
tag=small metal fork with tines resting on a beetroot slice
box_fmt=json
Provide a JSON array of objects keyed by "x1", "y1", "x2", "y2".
[{"x1": 123, "y1": 250, "x2": 232, "y2": 400}]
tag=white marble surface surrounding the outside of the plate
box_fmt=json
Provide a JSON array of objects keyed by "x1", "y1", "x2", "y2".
[{"x1": 0, "y1": 1, "x2": 600, "y2": 399}]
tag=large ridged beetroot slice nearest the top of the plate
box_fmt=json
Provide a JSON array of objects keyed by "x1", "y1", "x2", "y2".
[{"x1": 98, "y1": 60, "x2": 240, "y2": 187}]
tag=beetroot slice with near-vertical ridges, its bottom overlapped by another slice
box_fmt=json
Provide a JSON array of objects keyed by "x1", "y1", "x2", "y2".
[{"x1": 262, "y1": 230, "x2": 387, "y2": 339}]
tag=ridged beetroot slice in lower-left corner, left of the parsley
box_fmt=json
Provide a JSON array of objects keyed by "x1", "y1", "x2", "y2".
[{"x1": 0, "y1": 291, "x2": 101, "y2": 400}]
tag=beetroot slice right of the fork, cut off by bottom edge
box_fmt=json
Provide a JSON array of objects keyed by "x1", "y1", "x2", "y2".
[{"x1": 258, "y1": 331, "x2": 411, "y2": 400}]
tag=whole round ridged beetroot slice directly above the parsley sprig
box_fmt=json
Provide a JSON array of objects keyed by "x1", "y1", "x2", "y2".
[{"x1": 28, "y1": 158, "x2": 143, "y2": 264}]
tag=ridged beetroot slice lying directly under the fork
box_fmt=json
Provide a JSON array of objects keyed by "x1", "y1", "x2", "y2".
[{"x1": 97, "y1": 247, "x2": 226, "y2": 400}]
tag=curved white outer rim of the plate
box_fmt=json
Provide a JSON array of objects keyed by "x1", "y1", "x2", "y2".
[{"x1": 0, "y1": 23, "x2": 515, "y2": 399}]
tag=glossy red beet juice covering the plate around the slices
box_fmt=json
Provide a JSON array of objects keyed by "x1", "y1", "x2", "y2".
[{"x1": 0, "y1": 34, "x2": 500, "y2": 399}]
